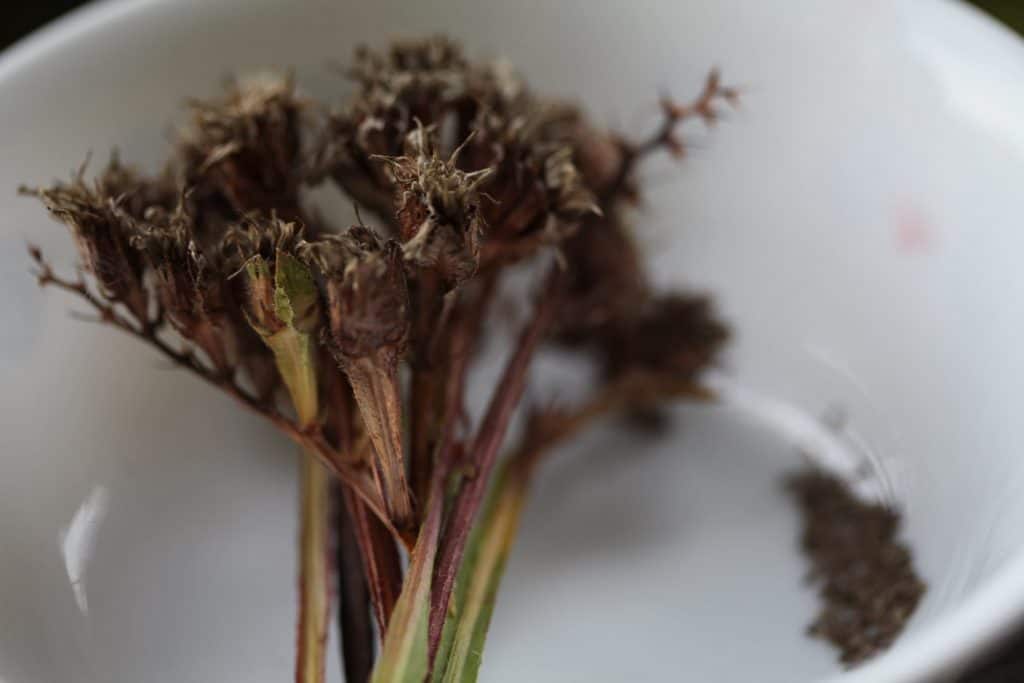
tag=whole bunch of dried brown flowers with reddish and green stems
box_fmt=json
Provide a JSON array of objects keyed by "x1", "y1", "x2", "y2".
[{"x1": 25, "y1": 38, "x2": 736, "y2": 681}]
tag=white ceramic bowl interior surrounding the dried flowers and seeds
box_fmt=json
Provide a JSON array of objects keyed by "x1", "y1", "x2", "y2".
[{"x1": 0, "y1": 0, "x2": 1024, "y2": 683}]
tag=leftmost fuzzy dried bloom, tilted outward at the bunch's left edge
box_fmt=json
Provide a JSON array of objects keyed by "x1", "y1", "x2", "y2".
[{"x1": 22, "y1": 157, "x2": 169, "y2": 324}]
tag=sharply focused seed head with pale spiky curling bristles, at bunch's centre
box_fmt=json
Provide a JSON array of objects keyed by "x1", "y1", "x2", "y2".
[{"x1": 387, "y1": 127, "x2": 492, "y2": 288}]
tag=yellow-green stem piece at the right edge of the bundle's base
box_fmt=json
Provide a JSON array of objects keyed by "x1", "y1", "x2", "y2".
[{"x1": 433, "y1": 462, "x2": 529, "y2": 683}]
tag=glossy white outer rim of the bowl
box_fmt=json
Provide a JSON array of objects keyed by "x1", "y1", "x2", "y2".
[{"x1": 6, "y1": 0, "x2": 1024, "y2": 683}]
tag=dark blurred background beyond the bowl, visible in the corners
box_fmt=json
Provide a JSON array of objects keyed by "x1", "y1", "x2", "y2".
[{"x1": 6, "y1": 0, "x2": 1024, "y2": 683}]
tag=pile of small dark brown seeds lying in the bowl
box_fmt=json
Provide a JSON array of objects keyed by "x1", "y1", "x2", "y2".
[{"x1": 787, "y1": 469, "x2": 925, "y2": 665}]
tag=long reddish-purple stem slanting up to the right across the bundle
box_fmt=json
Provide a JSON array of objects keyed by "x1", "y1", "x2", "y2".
[{"x1": 429, "y1": 270, "x2": 561, "y2": 660}]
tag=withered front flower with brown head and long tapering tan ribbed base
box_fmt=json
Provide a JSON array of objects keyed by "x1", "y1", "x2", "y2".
[{"x1": 305, "y1": 226, "x2": 415, "y2": 528}]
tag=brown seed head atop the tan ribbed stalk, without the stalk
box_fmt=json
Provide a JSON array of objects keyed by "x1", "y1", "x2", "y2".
[{"x1": 306, "y1": 226, "x2": 410, "y2": 364}]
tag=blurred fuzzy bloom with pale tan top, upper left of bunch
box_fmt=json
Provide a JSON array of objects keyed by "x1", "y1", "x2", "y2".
[{"x1": 180, "y1": 75, "x2": 303, "y2": 217}]
